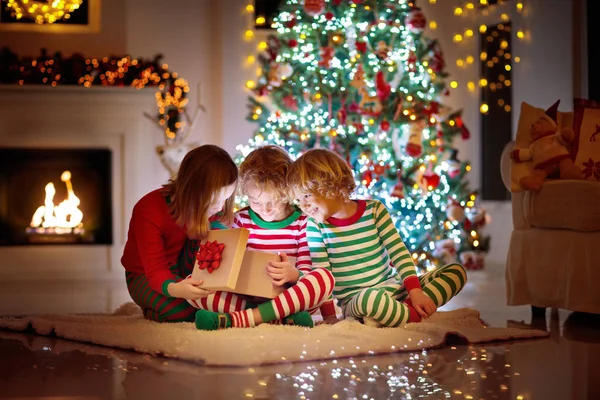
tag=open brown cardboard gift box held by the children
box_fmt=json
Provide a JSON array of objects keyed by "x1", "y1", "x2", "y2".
[{"x1": 192, "y1": 228, "x2": 296, "y2": 299}]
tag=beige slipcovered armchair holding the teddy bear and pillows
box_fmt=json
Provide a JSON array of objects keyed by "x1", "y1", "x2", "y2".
[{"x1": 501, "y1": 103, "x2": 600, "y2": 315}]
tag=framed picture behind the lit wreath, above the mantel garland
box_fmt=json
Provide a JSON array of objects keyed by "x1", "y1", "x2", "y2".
[{"x1": 0, "y1": 0, "x2": 102, "y2": 33}]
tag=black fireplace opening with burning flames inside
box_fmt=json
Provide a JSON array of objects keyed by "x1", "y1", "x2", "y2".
[{"x1": 0, "y1": 148, "x2": 112, "y2": 246}]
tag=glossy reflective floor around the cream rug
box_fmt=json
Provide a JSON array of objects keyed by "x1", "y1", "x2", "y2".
[{"x1": 0, "y1": 266, "x2": 600, "y2": 400}]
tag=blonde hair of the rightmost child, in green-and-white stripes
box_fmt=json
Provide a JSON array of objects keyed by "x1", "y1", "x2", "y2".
[{"x1": 287, "y1": 149, "x2": 356, "y2": 199}]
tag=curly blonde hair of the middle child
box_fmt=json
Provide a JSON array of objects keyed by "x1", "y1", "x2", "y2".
[{"x1": 240, "y1": 145, "x2": 292, "y2": 201}]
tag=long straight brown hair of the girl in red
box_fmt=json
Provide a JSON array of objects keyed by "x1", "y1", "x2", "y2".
[{"x1": 163, "y1": 144, "x2": 238, "y2": 239}]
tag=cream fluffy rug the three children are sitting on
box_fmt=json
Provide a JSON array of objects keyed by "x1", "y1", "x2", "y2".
[{"x1": 0, "y1": 303, "x2": 548, "y2": 366}]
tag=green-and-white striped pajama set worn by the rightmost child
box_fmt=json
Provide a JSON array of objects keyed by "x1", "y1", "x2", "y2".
[{"x1": 306, "y1": 200, "x2": 467, "y2": 326}]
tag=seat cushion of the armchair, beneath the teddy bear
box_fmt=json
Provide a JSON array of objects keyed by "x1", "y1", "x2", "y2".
[{"x1": 523, "y1": 180, "x2": 600, "y2": 232}]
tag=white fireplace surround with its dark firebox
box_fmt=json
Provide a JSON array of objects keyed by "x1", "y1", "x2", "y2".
[{"x1": 0, "y1": 85, "x2": 169, "y2": 282}]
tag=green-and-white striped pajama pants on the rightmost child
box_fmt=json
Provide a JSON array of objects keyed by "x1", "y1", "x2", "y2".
[{"x1": 342, "y1": 264, "x2": 467, "y2": 327}]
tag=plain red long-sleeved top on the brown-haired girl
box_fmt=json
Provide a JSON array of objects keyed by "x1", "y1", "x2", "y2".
[{"x1": 121, "y1": 189, "x2": 187, "y2": 297}]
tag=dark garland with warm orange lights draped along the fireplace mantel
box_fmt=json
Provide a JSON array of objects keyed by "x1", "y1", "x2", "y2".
[{"x1": 0, "y1": 47, "x2": 190, "y2": 142}]
